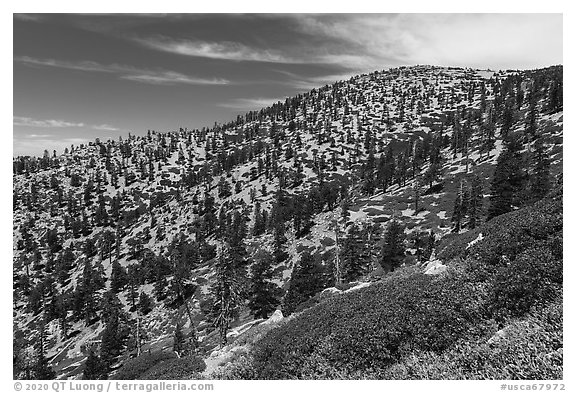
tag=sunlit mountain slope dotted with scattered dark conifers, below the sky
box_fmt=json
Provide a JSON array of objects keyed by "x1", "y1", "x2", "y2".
[{"x1": 13, "y1": 66, "x2": 563, "y2": 378}]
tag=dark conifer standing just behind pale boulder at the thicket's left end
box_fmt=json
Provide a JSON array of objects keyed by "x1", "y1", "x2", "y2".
[{"x1": 248, "y1": 249, "x2": 281, "y2": 318}]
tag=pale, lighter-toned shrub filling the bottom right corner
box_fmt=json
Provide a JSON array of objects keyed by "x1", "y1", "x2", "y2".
[{"x1": 380, "y1": 299, "x2": 563, "y2": 380}]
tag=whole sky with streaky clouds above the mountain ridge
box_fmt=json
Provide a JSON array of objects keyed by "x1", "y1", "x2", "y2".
[{"x1": 13, "y1": 14, "x2": 563, "y2": 156}]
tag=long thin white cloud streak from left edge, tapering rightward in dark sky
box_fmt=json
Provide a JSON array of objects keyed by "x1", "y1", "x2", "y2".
[{"x1": 14, "y1": 56, "x2": 230, "y2": 85}]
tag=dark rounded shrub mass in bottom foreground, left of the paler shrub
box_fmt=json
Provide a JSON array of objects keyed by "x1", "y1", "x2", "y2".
[{"x1": 254, "y1": 274, "x2": 490, "y2": 379}]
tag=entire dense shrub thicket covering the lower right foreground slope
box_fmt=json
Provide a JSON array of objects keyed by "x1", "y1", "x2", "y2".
[{"x1": 238, "y1": 193, "x2": 562, "y2": 379}]
